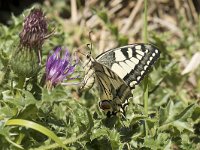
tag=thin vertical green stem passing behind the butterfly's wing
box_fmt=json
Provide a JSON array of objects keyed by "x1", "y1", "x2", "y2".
[{"x1": 143, "y1": 0, "x2": 149, "y2": 135}]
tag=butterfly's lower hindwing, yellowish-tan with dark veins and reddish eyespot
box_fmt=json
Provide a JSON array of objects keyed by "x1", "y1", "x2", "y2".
[{"x1": 93, "y1": 61, "x2": 132, "y2": 116}]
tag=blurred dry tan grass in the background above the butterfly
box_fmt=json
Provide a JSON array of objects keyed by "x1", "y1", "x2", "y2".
[{"x1": 45, "y1": 0, "x2": 200, "y2": 99}]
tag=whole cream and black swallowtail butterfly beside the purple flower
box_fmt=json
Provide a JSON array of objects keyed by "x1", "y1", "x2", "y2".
[{"x1": 80, "y1": 43, "x2": 160, "y2": 117}]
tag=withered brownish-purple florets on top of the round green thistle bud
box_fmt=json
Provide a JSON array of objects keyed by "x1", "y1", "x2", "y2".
[{"x1": 19, "y1": 8, "x2": 48, "y2": 48}]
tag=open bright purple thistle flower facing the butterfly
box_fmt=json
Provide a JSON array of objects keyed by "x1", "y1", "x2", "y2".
[{"x1": 46, "y1": 47, "x2": 78, "y2": 88}]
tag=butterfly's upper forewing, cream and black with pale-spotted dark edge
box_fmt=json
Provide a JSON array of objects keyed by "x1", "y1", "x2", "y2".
[{"x1": 96, "y1": 43, "x2": 160, "y2": 89}]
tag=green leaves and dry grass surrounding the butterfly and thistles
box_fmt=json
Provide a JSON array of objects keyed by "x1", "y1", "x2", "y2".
[{"x1": 0, "y1": 0, "x2": 200, "y2": 150}]
